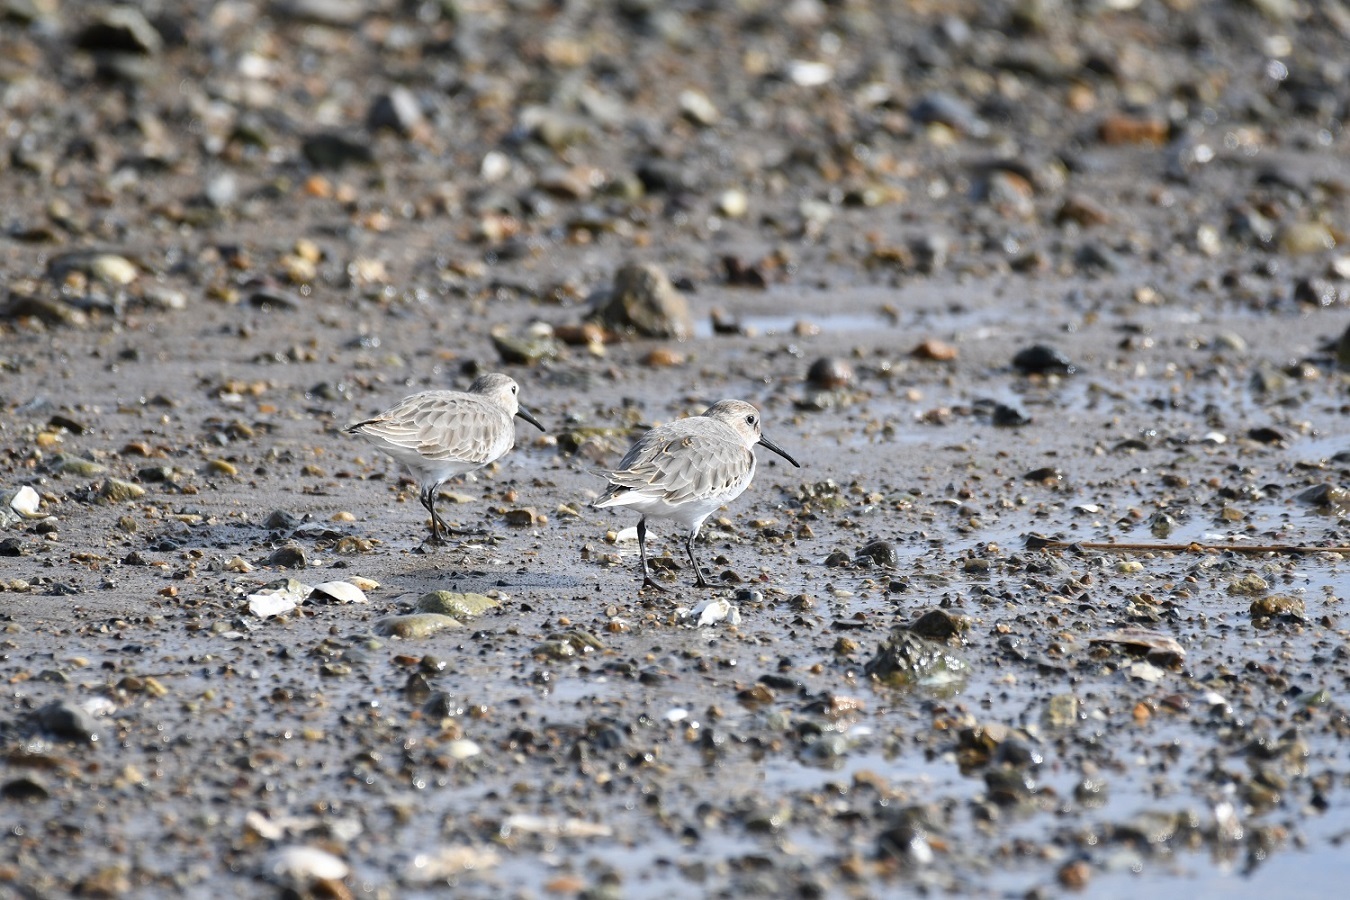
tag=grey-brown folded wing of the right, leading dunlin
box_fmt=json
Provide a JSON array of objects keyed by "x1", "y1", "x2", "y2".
[{"x1": 609, "y1": 432, "x2": 752, "y2": 503}]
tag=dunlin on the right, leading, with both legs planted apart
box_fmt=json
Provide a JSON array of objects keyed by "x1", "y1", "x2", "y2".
[{"x1": 594, "y1": 399, "x2": 801, "y2": 590}]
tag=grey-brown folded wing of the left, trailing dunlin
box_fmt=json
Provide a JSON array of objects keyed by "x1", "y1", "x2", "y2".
[{"x1": 358, "y1": 394, "x2": 510, "y2": 463}]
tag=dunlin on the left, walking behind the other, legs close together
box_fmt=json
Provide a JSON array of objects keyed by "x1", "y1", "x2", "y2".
[{"x1": 347, "y1": 372, "x2": 544, "y2": 544}]
